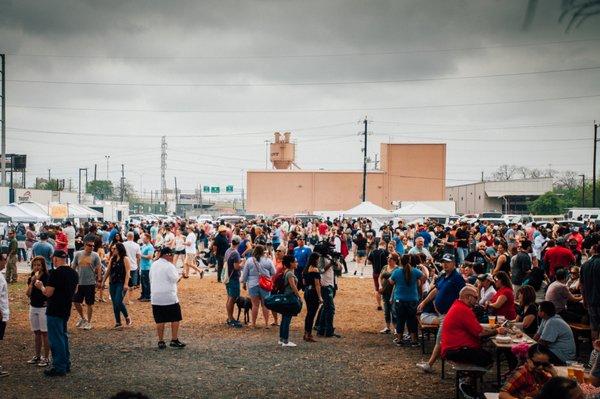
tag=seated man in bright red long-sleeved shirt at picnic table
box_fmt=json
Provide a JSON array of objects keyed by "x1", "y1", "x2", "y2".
[{"x1": 441, "y1": 285, "x2": 506, "y2": 367}]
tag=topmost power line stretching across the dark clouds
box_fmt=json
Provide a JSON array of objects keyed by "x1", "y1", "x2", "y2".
[{"x1": 6, "y1": 38, "x2": 600, "y2": 60}]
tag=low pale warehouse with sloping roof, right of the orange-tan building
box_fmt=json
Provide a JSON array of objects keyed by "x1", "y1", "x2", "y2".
[{"x1": 446, "y1": 177, "x2": 552, "y2": 214}]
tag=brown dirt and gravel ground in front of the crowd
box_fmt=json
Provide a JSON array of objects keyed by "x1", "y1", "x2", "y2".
[{"x1": 0, "y1": 275, "x2": 454, "y2": 398}]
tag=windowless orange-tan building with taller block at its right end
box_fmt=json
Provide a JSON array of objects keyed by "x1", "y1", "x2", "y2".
[{"x1": 246, "y1": 143, "x2": 446, "y2": 214}]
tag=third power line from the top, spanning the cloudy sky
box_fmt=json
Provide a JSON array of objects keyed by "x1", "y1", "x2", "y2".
[{"x1": 7, "y1": 94, "x2": 600, "y2": 114}]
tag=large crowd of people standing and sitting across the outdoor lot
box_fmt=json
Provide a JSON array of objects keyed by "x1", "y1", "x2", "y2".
[{"x1": 0, "y1": 218, "x2": 600, "y2": 398}]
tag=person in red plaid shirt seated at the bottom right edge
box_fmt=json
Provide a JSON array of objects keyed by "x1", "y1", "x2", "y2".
[{"x1": 498, "y1": 344, "x2": 556, "y2": 399}]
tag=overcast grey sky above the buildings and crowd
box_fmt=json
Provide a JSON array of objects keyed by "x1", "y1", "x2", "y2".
[{"x1": 0, "y1": 0, "x2": 600, "y2": 198}]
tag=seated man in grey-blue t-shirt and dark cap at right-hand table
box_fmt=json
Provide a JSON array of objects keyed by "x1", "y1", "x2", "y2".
[{"x1": 533, "y1": 301, "x2": 575, "y2": 366}]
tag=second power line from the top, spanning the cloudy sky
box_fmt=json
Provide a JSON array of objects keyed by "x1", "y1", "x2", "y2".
[{"x1": 7, "y1": 66, "x2": 600, "y2": 88}]
